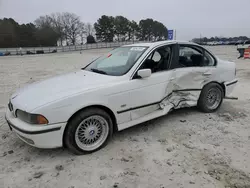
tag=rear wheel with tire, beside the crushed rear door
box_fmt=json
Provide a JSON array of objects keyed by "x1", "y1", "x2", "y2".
[{"x1": 197, "y1": 83, "x2": 224, "y2": 113}]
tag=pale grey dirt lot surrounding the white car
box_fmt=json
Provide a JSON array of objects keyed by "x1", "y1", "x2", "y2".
[{"x1": 0, "y1": 46, "x2": 250, "y2": 188}]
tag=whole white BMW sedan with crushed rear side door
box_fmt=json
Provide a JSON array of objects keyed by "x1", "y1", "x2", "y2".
[{"x1": 6, "y1": 41, "x2": 237, "y2": 154}]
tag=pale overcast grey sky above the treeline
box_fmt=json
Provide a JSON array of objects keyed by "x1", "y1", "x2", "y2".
[{"x1": 0, "y1": 0, "x2": 250, "y2": 40}]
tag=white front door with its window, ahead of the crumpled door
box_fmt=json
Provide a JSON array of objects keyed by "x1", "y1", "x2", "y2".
[{"x1": 130, "y1": 45, "x2": 174, "y2": 120}]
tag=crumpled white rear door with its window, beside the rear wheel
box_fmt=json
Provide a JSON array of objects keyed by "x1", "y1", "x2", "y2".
[{"x1": 166, "y1": 44, "x2": 215, "y2": 108}]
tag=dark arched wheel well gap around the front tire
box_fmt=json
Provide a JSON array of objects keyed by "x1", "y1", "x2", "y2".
[{"x1": 63, "y1": 105, "x2": 118, "y2": 147}]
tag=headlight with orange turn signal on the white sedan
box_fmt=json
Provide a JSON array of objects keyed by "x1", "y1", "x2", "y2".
[{"x1": 16, "y1": 110, "x2": 49, "y2": 125}]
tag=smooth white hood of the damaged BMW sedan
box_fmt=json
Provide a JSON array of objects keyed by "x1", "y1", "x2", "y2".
[{"x1": 11, "y1": 70, "x2": 116, "y2": 112}]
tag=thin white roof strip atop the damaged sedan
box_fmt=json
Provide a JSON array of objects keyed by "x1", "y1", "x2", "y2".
[{"x1": 124, "y1": 40, "x2": 199, "y2": 48}]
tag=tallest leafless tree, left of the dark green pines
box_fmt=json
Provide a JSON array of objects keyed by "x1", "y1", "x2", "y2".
[{"x1": 62, "y1": 12, "x2": 83, "y2": 45}]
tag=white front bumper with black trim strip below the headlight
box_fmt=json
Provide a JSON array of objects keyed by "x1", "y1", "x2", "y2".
[{"x1": 5, "y1": 110, "x2": 66, "y2": 148}]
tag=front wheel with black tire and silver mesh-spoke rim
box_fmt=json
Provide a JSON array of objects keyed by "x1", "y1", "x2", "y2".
[{"x1": 64, "y1": 108, "x2": 113, "y2": 155}]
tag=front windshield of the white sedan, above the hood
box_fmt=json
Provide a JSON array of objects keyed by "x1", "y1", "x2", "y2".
[{"x1": 84, "y1": 46, "x2": 147, "y2": 76}]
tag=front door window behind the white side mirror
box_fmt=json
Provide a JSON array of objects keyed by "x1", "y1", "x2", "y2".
[{"x1": 140, "y1": 45, "x2": 172, "y2": 73}]
